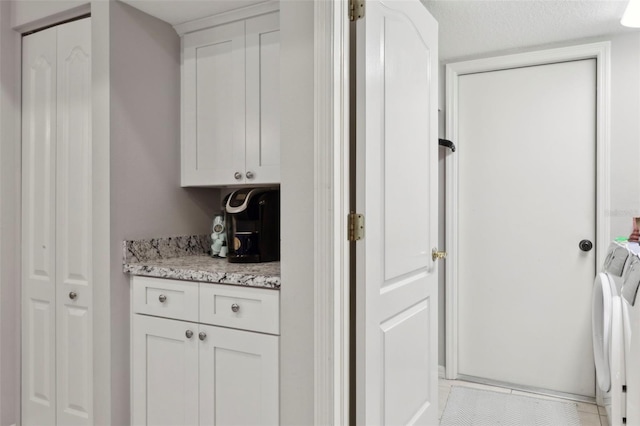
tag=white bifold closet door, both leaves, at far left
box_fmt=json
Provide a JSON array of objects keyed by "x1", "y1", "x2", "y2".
[{"x1": 22, "y1": 19, "x2": 93, "y2": 425}]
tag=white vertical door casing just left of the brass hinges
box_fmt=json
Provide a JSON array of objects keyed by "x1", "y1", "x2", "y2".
[{"x1": 314, "y1": 0, "x2": 349, "y2": 425}]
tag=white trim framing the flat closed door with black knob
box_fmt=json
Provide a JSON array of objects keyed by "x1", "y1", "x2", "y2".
[{"x1": 445, "y1": 42, "x2": 611, "y2": 379}]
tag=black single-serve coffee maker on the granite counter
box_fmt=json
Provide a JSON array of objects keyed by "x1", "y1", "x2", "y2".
[{"x1": 225, "y1": 188, "x2": 280, "y2": 263}]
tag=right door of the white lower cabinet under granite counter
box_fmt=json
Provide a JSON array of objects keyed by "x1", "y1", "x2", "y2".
[{"x1": 200, "y1": 325, "x2": 279, "y2": 426}]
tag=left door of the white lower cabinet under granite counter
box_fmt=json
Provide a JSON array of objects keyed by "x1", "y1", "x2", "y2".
[{"x1": 131, "y1": 315, "x2": 199, "y2": 426}]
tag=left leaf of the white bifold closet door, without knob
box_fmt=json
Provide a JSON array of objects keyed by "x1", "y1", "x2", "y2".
[{"x1": 22, "y1": 28, "x2": 57, "y2": 425}]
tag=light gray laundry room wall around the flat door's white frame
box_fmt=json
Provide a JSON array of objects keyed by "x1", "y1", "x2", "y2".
[{"x1": 439, "y1": 33, "x2": 640, "y2": 365}]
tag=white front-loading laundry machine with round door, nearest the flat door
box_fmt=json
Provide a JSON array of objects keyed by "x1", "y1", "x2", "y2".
[{"x1": 592, "y1": 243, "x2": 640, "y2": 426}]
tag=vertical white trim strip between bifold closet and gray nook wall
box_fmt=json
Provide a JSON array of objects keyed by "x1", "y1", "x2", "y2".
[{"x1": 91, "y1": 0, "x2": 113, "y2": 425}]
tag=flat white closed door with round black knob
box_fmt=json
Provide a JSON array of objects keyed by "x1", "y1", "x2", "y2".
[{"x1": 456, "y1": 60, "x2": 596, "y2": 397}]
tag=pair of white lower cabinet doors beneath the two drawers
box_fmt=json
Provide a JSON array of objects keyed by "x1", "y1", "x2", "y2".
[{"x1": 131, "y1": 283, "x2": 279, "y2": 426}]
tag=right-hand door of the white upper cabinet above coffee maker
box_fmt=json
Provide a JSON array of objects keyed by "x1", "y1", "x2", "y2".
[{"x1": 245, "y1": 13, "x2": 280, "y2": 183}]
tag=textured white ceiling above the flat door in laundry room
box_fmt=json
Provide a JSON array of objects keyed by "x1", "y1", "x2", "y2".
[{"x1": 422, "y1": 0, "x2": 638, "y2": 62}]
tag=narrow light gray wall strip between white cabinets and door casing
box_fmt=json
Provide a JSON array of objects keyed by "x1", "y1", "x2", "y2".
[{"x1": 280, "y1": 0, "x2": 315, "y2": 425}]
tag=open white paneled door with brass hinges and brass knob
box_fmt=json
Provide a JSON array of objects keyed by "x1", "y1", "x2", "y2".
[{"x1": 355, "y1": 0, "x2": 438, "y2": 425}]
